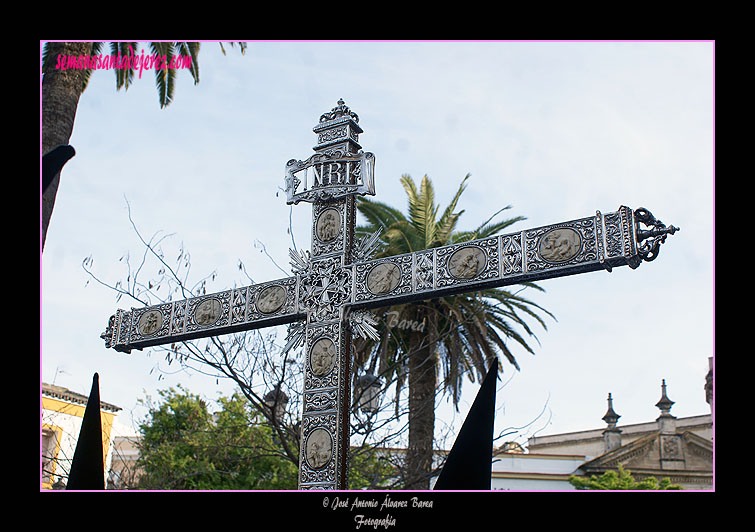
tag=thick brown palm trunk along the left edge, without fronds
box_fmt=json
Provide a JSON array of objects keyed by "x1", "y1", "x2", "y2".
[{"x1": 42, "y1": 42, "x2": 92, "y2": 249}]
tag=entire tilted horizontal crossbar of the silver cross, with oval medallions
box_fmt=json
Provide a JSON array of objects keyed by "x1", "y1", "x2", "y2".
[{"x1": 102, "y1": 206, "x2": 677, "y2": 353}]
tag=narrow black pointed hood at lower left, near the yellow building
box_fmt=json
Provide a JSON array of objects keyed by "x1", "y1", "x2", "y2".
[{"x1": 66, "y1": 373, "x2": 105, "y2": 490}]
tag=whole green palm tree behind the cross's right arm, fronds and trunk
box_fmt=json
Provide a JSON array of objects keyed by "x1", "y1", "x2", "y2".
[{"x1": 355, "y1": 175, "x2": 552, "y2": 489}]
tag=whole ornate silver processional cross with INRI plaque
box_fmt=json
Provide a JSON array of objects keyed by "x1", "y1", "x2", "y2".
[{"x1": 102, "y1": 100, "x2": 677, "y2": 489}]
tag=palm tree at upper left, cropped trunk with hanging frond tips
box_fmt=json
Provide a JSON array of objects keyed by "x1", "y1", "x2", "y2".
[{"x1": 41, "y1": 42, "x2": 246, "y2": 249}]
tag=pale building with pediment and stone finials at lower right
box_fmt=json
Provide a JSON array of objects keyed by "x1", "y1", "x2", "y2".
[{"x1": 491, "y1": 360, "x2": 714, "y2": 490}]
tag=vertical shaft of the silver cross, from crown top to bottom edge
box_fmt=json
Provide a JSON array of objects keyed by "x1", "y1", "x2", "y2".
[{"x1": 299, "y1": 100, "x2": 362, "y2": 489}]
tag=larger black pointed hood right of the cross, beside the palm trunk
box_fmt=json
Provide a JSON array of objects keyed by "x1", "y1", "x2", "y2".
[{"x1": 433, "y1": 362, "x2": 498, "y2": 490}]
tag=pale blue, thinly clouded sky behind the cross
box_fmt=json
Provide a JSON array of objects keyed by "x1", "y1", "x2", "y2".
[{"x1": 40, "y1": 42, "x2": 714, "y2": 437}]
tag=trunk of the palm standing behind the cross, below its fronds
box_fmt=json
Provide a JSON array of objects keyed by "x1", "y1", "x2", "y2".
[{"x1": 405, "y1": 316, "x2": 438, "y2": 490}]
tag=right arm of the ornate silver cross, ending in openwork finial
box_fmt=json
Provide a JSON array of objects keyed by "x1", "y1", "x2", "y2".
[{"x1": 351, "y1": 206, "x2": 677, "y2": 309}]
